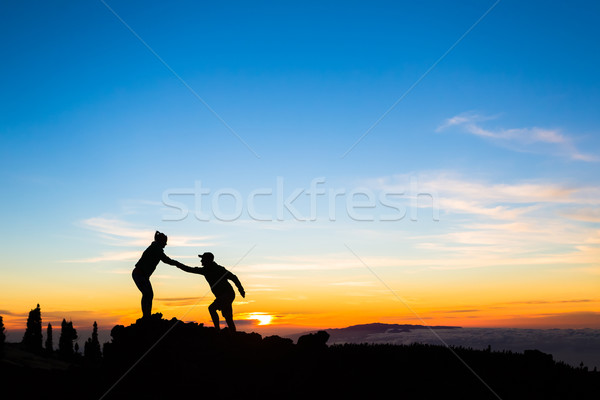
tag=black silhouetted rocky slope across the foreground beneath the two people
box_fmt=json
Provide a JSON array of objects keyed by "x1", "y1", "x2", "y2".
[{"x1": 0, "y1": 318, "x2": 600, "y2": 399}]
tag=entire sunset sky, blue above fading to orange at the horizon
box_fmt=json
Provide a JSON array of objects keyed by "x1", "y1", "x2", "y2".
[{"x1": 0, "y1": 0, "x2": 600, "y2": 341}]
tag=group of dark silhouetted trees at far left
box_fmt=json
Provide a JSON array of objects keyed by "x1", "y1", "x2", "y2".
[{"x1": 0, "y1": 304, "x2": 102, "y2": 361}]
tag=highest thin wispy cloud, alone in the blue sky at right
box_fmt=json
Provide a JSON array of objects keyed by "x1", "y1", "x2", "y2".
[{"x1": 436, "y1": 113, "x2": 600, "y2": 162}]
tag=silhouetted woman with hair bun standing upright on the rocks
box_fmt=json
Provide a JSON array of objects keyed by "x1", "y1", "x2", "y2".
[{"x1": 131, "y1": 231, "x2": 183, "y2": 318}]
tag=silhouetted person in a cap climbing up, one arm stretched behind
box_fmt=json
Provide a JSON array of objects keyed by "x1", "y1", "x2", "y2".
[{"x1": 177, "y1": 253, "x2": 246, "y2": 332}]
